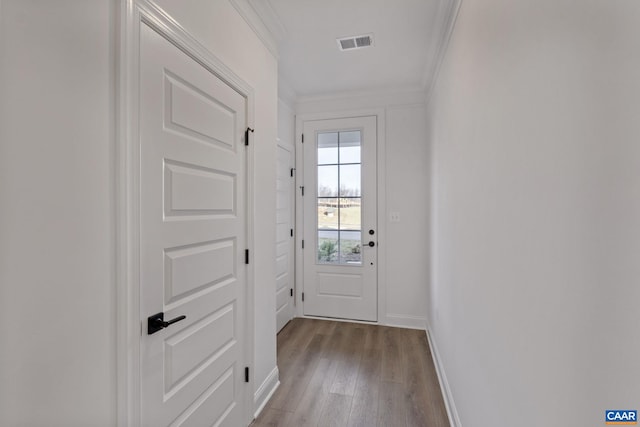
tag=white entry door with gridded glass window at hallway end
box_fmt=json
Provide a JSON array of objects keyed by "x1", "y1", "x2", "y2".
[{"x1": 303, "y1": 117, "x2": 378, "y2": 321}]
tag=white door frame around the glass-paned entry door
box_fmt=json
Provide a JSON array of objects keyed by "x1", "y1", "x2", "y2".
[{"x1": 295, "y1": 108, "x2": 387, "y2": 325}]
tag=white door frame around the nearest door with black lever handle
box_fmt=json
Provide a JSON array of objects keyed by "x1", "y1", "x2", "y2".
[{"x1": 114, "y1": 0, "x2": 255, "y2": 427}]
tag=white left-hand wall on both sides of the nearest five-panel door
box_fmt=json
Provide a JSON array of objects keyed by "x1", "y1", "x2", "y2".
[{"x1": 0, "y1": 0, "x2": 277, "y2": 427}]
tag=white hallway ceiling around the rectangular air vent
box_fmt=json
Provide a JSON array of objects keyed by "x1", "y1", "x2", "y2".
[{"x1": 249, "y1": 0, "x2": 451, "y2": 96}]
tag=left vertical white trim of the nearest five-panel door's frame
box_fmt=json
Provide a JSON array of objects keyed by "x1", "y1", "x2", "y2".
[{"x1": 116, "y1": 0, "x2": 141, "y2": 427}]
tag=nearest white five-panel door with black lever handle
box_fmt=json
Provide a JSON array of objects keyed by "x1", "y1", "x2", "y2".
[{"x1": 140, "y1": 24, "x2": 247, "y2": 427}]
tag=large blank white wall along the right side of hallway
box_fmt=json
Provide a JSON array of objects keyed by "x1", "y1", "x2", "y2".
[{"x1": 429, "y1": 0, "x2": 640, "y2": 427}]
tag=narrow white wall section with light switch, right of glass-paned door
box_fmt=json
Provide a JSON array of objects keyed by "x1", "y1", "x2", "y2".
[{"x1": 379, "y1": 105, "x2": 430, "y2": 327}]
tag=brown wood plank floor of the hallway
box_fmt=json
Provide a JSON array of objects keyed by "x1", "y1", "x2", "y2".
[{"x1": 251, "y1": 318, "x2": 449, "y2": 427}]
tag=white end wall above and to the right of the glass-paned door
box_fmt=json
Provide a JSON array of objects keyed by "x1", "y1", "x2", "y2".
[{"x1": 296, "y1": 91, "x2": 430, "y2": 328}]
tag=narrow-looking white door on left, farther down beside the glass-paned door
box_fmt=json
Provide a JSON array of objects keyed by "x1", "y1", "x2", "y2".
[{"x1": 276, "y1": 145, "x2": 294, "y2": 331}]
